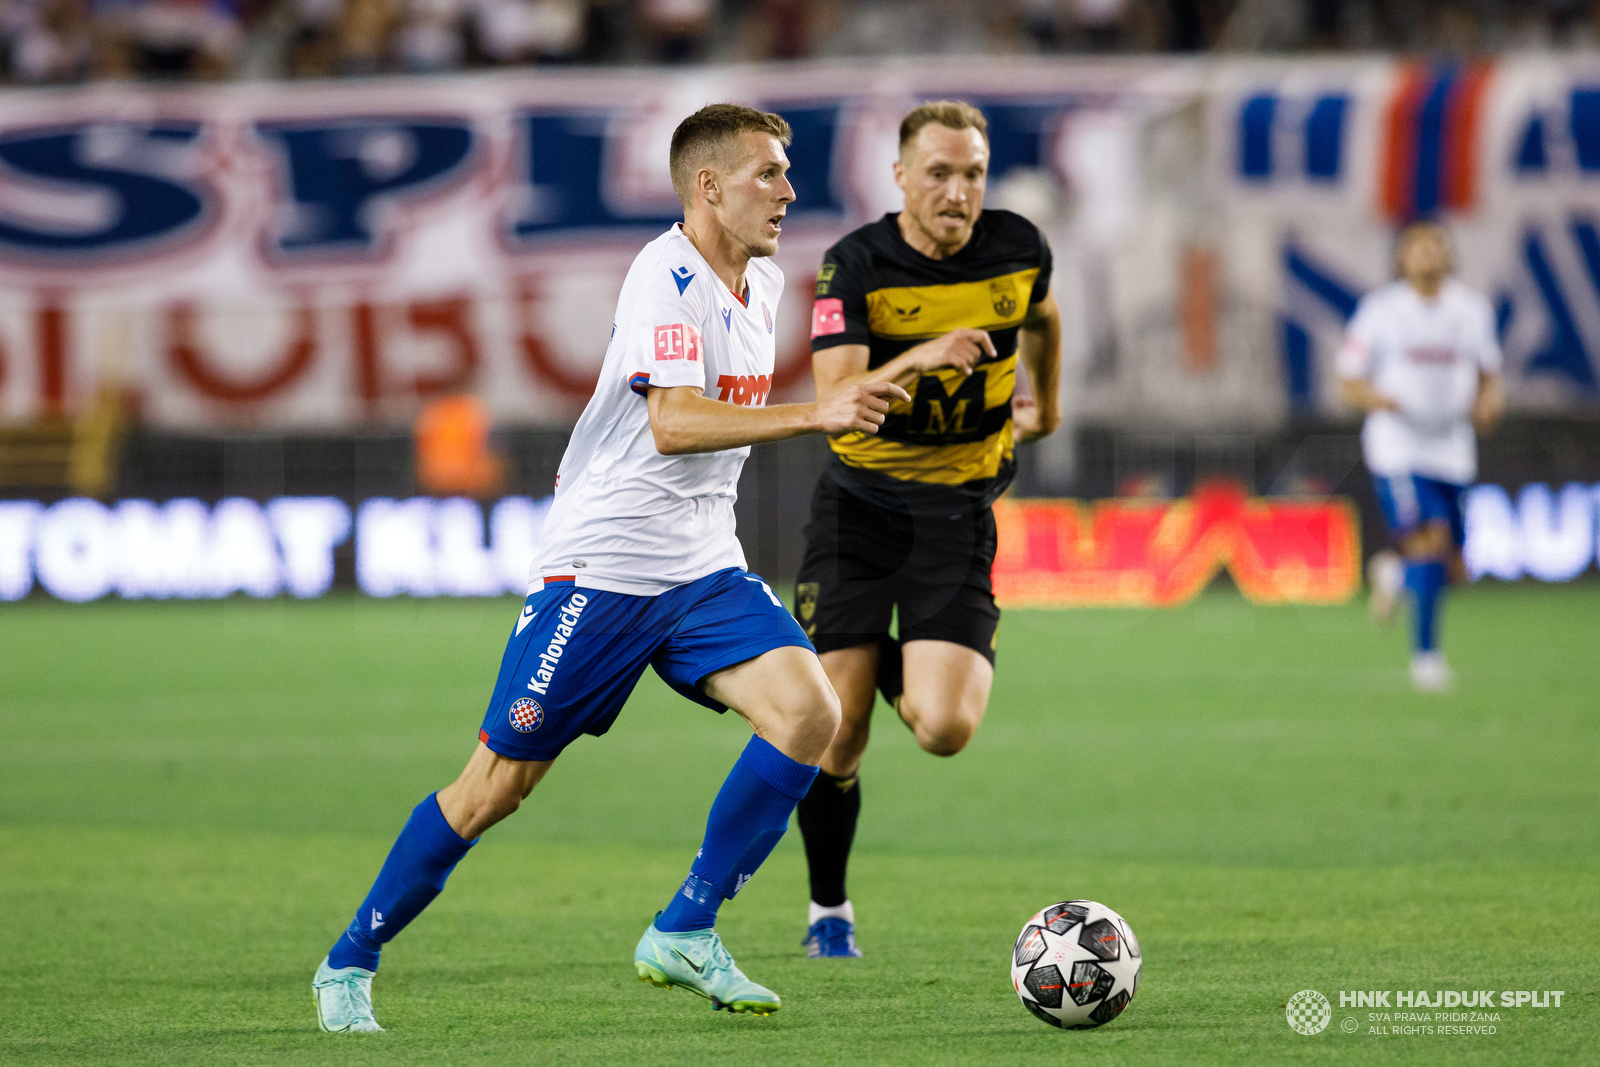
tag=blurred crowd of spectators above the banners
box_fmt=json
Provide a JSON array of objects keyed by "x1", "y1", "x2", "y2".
[{"x1": 0, "y1": 0, "x2": 1600, "y2": 85}]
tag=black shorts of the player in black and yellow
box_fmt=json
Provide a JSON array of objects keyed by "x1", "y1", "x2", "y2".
[{"x1": 795, "y1": 475, "x2": 1000, "y2": 664}]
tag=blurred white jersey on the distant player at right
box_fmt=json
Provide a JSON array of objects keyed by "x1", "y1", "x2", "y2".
[{"x1": 1338, "y1": 278, "x2": 1501, "y2": 485}]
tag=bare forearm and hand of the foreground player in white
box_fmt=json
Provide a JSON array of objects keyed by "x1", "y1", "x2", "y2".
[{"x1": 650, "y1": 382, "x2": 910, "y2": 456}]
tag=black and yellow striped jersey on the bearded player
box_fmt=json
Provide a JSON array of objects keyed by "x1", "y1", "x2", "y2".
[{"x1": 811, "y1": 211, "x2": 1051, "y2": 510}]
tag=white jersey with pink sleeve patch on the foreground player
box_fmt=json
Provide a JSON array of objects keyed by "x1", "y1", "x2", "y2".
[{"x1": 531, "y1": 224, "x2": 784, "y2": 595}]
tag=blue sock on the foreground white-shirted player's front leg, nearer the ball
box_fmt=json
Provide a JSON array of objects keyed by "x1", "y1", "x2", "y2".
[{"x1": 656, "y1": 737, "x2": 818, "y2": 933}]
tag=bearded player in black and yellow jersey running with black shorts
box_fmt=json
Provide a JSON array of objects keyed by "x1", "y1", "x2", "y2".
[{"x1": 795, "y1": 101, "x2": 1061, "y2": 957}]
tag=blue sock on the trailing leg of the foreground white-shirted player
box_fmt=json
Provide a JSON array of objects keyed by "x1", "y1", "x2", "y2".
[{"x1": 328, "y1": 793, "x2": 477, "y2": 971}]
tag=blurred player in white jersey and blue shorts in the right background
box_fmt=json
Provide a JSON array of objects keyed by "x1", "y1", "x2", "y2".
[{"x1": 1338, "y1": 222, "x2": 1506, "y2": 691}]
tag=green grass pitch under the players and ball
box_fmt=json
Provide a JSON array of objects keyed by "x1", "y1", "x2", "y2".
[{"x1": 0, "y1": 582, "x2": 1600, "y2": 1065}]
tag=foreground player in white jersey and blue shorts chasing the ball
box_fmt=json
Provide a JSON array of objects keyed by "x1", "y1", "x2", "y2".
[{"x1": 312, "y1": 104, "x2": 907, "y2": 1032}]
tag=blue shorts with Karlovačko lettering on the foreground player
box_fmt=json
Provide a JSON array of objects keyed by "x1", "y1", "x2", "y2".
[{"x1": 478, "y1": 568, "x2": 811, "y2": 760}]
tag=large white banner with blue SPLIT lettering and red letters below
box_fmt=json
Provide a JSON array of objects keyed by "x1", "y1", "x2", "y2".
[{"x1": 0, "y1": 64, "x2": 1147, "y2": 430}]
